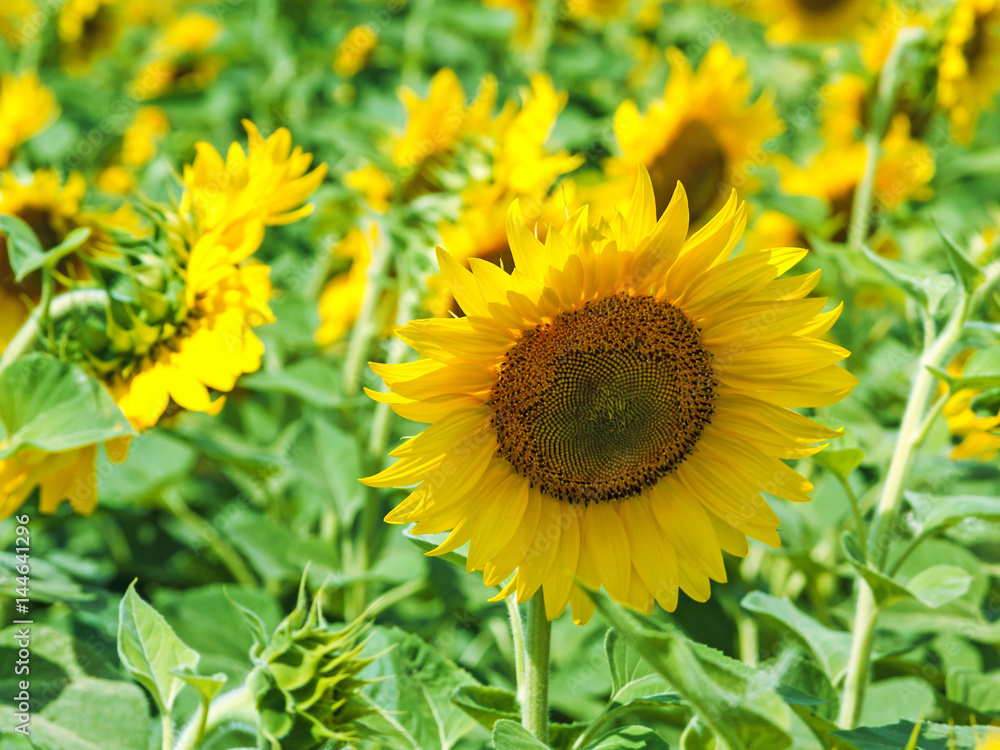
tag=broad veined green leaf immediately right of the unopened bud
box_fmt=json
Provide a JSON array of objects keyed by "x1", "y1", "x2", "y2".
[{"x1": 361, "y1": 628, "x2": 476, "y2": 750}]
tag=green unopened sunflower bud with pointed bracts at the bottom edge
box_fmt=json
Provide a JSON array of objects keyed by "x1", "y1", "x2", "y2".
[{"x1": 247, "y1": 576, "x2": 375, "y2": 750}]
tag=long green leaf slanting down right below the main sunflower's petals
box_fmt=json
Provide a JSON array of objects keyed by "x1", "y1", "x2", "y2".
[{"x1": 591, "y1": 593, "x2": 791, "y2": 750}]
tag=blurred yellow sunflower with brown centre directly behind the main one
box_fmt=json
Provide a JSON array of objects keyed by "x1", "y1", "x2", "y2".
[{"x1": 594, "y1": 42, "x2": 784, "y2": 225}]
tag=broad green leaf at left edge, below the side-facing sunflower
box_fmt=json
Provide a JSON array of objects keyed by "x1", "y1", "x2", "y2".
[{"x1": 0, "y1": 354, "x2": 135, "y2": 460}]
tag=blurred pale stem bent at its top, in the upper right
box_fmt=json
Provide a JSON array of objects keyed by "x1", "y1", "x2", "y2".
[{"x1": 847, "y1": 26, "x2": 924, "y2": 248}]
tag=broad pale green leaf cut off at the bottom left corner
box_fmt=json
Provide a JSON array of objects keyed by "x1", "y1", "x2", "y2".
[{"x1": 25, "y1": 678, "x2": 150, "y2": 750}]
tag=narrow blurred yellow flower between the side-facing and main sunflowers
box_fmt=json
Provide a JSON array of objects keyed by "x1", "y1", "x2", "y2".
[{"x1": 316, "y1": 223, "x2": 379, "y2": 346}]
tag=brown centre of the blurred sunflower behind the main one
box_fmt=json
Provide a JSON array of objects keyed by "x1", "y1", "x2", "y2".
[{"x1": 649, "y1": 120, "x2": 726, "y2": 220}]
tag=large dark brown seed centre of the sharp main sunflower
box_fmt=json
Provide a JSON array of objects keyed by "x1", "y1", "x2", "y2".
[{"x1": 490, "y1": 293, "x2": 716, "y2": 503}]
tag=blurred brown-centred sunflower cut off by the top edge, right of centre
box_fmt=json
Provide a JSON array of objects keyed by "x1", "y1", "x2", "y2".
[{"x1": 751, "y1": 0, "x2": 875, "y2": 44}]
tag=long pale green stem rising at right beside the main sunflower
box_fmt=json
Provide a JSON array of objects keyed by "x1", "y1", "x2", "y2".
[{"x1": 837, "y1": 293, "x2": 969, "y2": 729}]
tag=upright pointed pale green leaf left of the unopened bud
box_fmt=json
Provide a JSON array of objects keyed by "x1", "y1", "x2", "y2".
[{"x1": 118, "y1": 581, "x2": 198, "y2": 713}]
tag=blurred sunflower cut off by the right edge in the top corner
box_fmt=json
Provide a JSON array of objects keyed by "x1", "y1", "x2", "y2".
[{"x1": 937, "y1": 0, "x2": 1000, "y2": 143}]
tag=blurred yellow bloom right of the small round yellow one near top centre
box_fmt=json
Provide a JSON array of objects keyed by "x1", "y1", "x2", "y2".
[{"x1": 392, "y1": 68, "x2": 497, "y2": 169}]
